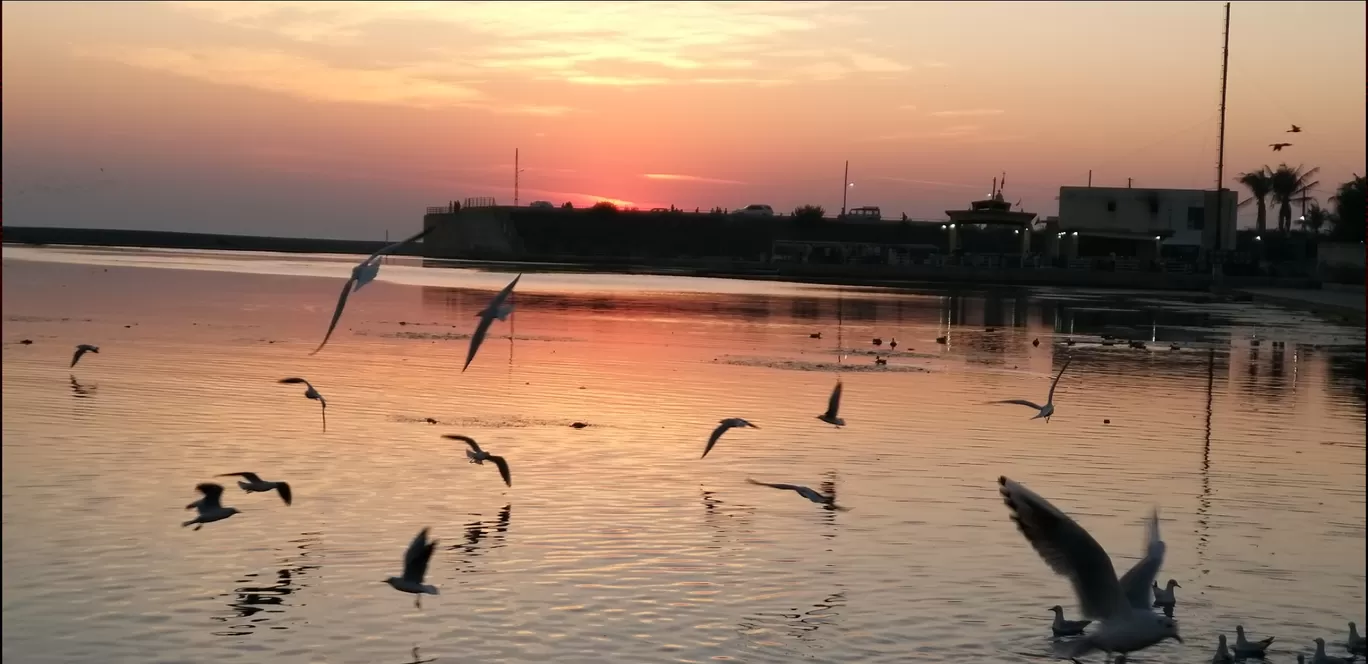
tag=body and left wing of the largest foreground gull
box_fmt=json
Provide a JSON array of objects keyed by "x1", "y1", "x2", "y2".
[{"x1": 997, "y1": 478, "x2": 1183, "y2": 659}]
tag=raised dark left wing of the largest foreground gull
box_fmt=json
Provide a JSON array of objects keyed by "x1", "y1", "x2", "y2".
[{"x1": 997, "y1": 478, "x2": 1130, "y2": 620}]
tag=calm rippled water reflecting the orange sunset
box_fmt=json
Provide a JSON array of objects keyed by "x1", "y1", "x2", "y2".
[{"x1": 3, "y1": 246, "x2": 1365, "y2": 664}]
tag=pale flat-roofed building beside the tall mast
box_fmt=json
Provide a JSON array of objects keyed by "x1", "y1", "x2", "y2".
[{"x1": 1059, "y1": 186, "x2": 1239, "y2": 251}]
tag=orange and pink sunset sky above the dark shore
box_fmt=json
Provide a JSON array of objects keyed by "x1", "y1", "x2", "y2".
[{"x1": 3, "y1": 1, "x2": 1368, "y2": 238}]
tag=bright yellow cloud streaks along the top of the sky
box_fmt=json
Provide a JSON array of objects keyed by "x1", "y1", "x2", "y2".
[{"x1": 168, "y1": 1, "x2": 911, "y2": 86}]
